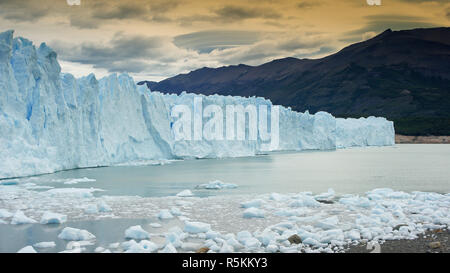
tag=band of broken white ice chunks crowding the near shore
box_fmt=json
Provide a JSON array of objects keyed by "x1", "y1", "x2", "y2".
[{"x1": 0, "y1": 178, "x2": 450, "y2": 252}]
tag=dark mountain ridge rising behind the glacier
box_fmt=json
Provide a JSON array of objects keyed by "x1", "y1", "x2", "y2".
[{"x1": 139, "y1": 27, "x2": 450, "y2": 135}]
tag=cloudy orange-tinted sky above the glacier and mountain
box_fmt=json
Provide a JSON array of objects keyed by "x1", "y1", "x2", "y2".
[{"x1": 0, "y1": 0, "x2": 450, "y2": 81}]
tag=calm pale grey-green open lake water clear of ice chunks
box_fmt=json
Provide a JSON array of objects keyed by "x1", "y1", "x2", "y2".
[{"x1": 0, "y1": 144, "x2": 450, "y2": 252}]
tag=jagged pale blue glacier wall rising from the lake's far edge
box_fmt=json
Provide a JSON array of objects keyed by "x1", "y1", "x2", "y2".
[{"x1": 0, "y1": 30, "x2": 395, "y2": 179}]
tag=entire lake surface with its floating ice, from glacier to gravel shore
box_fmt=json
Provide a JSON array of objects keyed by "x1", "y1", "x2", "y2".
[{"x1": 0, "y1": 145, "x2": 450, "y2": 253}]
